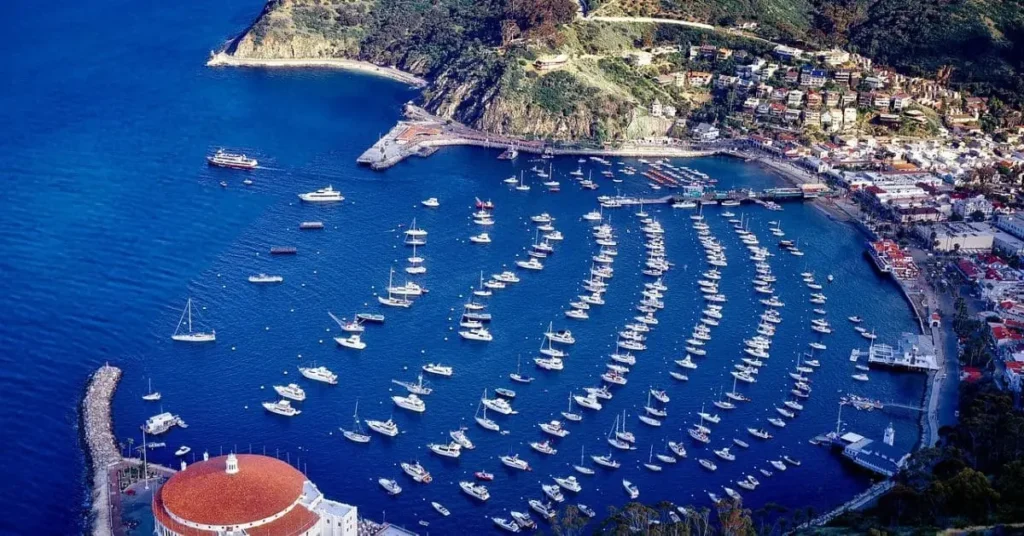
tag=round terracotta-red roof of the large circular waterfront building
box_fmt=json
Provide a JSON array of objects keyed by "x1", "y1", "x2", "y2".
[{"x1": 160, "y1": 454, "x2": 306, "y2": 525}]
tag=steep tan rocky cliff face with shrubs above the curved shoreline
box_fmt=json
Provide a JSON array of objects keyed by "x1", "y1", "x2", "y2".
[{"x1": 227, "y1": 0, "x2": 664, "y2": 139}]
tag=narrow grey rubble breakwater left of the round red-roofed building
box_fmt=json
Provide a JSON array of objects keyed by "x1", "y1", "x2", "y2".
[{"x1": 82, "y1": 365, "x2": 121, "y2": 536}]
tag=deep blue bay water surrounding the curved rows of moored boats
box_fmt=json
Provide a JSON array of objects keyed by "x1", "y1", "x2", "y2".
[{"x1": 0, "y1": 0, "x2": 923, "y2": 534}]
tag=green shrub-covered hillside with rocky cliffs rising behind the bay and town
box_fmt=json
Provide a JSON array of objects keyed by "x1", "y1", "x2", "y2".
[{"x1": 228, "y1": 0, "x2": 1024, "y2": 141}]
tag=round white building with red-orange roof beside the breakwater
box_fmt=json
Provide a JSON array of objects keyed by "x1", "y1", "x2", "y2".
[{"x1": 153, "y1": 454, "x2": 358, "y2": 536}]
